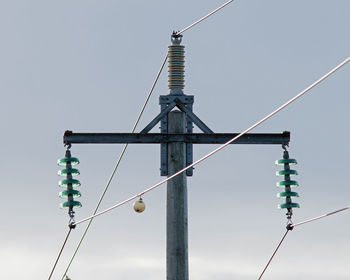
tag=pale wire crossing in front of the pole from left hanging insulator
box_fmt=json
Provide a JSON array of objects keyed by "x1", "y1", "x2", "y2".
[{"x1": 75, "y1": 57, "x2": 350, "y2": 225}]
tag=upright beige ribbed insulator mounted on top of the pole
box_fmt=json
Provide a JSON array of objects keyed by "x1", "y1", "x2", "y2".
[{"x1": 168, "y1": 35, "x2": 185, "y2": 94}]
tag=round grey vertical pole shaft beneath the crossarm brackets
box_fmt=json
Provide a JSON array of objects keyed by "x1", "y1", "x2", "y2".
[{"x1": 166, "y1": 111, "x2": 188, "y2": 280}]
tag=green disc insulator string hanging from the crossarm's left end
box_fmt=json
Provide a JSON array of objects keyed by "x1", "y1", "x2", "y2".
[{"x1": 57, "y1": 150, "x2": 81, "y2": 217}]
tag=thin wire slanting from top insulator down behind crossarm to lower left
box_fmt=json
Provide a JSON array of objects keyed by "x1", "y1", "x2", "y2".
[{"x1": 62, "y1": 53, "x2": 168, "y2": 280}]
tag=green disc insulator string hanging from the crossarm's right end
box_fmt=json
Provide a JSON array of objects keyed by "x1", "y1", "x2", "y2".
[{"x1": 276, "y1": 151, "x2": 299, "y2": 210}]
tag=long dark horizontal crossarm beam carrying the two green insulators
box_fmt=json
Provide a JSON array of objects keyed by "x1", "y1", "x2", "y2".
[{"x1": 63, "y1": 131, "x2": 290, "y2": 145}]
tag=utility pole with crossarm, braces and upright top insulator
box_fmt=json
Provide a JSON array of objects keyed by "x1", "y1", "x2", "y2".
[{"x1": 63, "y1": 32, "x2": 290, "y2": 280}]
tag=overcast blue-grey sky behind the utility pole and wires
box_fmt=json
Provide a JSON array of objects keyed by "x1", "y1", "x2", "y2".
[{"x1": 0, "y1": 0, "x2": 350, "y2": 280}]
